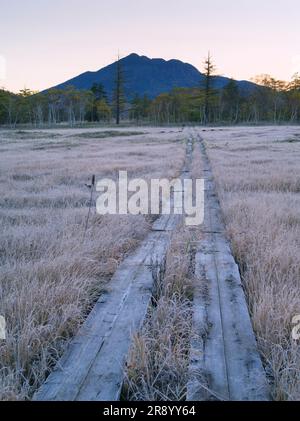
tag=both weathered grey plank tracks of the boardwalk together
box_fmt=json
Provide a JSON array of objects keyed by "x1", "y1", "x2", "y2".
[{"x1": 34, "y1": 133, "x2": 268, "y2": 401}]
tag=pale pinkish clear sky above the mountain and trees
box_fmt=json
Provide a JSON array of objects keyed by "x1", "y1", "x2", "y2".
[{"x1": 0, "y1": 0, "x2": 300, "y2": 91}]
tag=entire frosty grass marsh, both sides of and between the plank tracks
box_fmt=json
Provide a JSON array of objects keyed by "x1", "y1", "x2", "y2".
[{"x1": 0, "y1": 126, "x2": 300, "y2": 400}]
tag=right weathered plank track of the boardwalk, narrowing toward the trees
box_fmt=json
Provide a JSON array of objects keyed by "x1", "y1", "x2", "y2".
[{"x1": 187, "y1": 134, "x2": 269, "y2": 401}]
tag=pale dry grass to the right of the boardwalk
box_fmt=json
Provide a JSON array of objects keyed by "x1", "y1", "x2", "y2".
[{"x1": 199, "y1": 127, "x2": 300, "y2": 400}]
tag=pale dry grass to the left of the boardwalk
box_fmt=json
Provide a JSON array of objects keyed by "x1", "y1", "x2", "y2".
[{"x1": 0, "y1": 129, "x2": 185, "y2": 400}]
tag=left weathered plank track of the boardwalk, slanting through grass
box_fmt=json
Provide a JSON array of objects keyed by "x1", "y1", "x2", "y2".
[{"x1": 34, "y1": 137, "x2": 192, "y2": 401}]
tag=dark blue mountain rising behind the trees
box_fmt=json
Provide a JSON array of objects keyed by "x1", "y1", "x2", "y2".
[{"x1": 50, "y1": 53, "x2": 255, "y2": 99}]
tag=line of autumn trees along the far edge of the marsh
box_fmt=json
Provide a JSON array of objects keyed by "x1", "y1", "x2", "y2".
[{"x1": 0, "y1": 55, "x2": 300, "y2": 127}]
